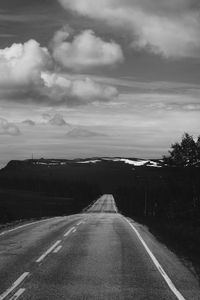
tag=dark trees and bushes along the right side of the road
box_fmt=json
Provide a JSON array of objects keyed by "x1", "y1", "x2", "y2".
[{"x1": 116, "y1": 133, "x2": 200, "y2": 278}]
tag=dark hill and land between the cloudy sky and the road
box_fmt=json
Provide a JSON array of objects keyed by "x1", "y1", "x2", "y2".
[{"x1": 0, "y1": 158, "x2": 200, "y2": 278}]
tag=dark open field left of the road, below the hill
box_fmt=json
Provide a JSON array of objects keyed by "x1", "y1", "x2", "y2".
[{"x1": 0, "y1": 190, "x2": 76, "y2": 226}]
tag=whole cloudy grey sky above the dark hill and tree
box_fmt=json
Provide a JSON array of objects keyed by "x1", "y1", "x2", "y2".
[{"x1": 0, "y1": 0, "x2": 200, "y2": 165}]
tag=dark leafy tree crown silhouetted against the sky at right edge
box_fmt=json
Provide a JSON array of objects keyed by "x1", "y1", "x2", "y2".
[{"x1": 163, "y1": 133, "x2": 200, "y2": 167}]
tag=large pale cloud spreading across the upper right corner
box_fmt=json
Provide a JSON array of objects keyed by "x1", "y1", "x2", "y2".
[{"x1": 58, "y1": 0, "x2": 200, "y2": 58}]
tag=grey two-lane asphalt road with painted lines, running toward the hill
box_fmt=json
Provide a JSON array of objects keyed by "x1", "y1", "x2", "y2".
[{"x1": 0, "y1": 195, "x2": 200, "y2": 300}]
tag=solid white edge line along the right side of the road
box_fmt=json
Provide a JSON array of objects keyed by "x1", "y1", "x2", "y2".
[{"x1": 123, "y1": 217, "x2": 186, "y2": 300}]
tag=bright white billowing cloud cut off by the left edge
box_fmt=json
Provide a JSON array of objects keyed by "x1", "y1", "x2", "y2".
[{"x1": 0, "y1": 40, "x2": 51, "y2": 89}]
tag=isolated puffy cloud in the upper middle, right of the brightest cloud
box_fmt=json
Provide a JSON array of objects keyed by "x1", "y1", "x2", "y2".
[{"x1": 52, "y1": 27, "x2": 123, "y2": 70}]
